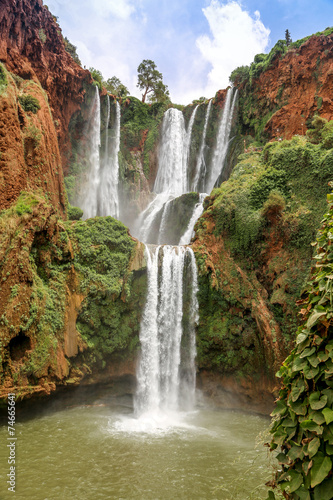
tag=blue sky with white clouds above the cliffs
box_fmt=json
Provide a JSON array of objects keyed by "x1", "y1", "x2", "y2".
[{"x1": 46, "y1": 0, "x2": 333, "y2": 104}]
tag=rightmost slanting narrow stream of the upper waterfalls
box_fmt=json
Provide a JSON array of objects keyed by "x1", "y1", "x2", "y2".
[{"x1": 205, "y1": 88, "x2": 237, "y2": 193}]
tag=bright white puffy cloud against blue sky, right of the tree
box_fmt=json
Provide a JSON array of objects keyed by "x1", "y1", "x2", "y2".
[{"x1": 196, "y1": 0, "x2": 270, "y2": 94}]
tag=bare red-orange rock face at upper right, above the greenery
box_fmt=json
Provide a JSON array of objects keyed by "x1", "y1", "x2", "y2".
[{"x1": 236, "y1": 34, "x2": 333, "y2": 139}]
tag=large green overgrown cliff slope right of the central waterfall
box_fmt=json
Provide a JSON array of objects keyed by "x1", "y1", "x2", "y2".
[{"x1": 196, "y1": 126, "x2": 333, "y2": 375}]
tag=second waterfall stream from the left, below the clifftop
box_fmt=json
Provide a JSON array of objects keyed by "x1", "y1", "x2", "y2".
[{"x1": 99, "y1": 95, "x2": 120, "y2": 218}]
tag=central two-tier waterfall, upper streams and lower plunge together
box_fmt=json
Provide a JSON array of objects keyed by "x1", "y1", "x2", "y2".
[{"x1": 121, "y1": 90, "x2": 236, "y2": 429}]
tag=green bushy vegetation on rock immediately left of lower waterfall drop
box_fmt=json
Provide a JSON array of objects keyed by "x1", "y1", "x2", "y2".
[{"x1": 67, "y1": 217, "x2": 146, "y2": 360}]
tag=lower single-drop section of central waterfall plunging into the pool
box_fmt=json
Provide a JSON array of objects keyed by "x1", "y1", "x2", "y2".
[{"x1": 135, "y1": 245, "x2": 198, "y2": 416}]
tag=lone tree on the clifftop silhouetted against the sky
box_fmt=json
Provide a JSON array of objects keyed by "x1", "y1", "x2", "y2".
[{"x1": 137, "y1": 59, "x2": 169, "y2": 102}]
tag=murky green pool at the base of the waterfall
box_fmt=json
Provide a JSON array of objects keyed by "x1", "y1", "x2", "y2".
[{"x1": 0, "y1": 395, "x2": 270, "y2": 500}]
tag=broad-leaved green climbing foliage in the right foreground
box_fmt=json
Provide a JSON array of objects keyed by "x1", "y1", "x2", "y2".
[{"x1": 269, "y1": 188, "x2": 333, "y2": 500}]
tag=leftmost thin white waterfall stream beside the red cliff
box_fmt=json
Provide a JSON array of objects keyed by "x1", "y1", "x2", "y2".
[{"x1": 83, "y1": 87, "x2": 101, "y2": 219}]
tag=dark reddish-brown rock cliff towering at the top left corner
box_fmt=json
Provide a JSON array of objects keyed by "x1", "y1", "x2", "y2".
[{"x1": 0, "y1": 0, "x2": 92, "y2": 169}]
